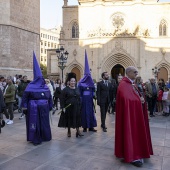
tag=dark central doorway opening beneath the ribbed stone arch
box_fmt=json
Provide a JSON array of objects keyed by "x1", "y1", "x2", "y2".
[{"x1": 111, "y1": 64, "x2": 125, "y2": 81}]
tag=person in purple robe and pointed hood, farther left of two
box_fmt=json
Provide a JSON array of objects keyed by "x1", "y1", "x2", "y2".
[{"x1": 22, "y1": 53, "x2": 53, "y2": 145}]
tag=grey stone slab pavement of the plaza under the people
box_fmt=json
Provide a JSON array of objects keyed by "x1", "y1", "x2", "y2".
[{"x1": 0, "y1": 108, "x2": 170, "y2": 170}]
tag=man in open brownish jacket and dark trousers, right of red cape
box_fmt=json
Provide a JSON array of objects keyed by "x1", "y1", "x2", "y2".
[{"x1": 146, "y1": 78, "x2": 159, "y2": 117}]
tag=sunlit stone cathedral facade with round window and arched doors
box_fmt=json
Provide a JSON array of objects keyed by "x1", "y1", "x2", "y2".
[{"x1": 48, "y1": 0, "x2": 170, "y2": 81}]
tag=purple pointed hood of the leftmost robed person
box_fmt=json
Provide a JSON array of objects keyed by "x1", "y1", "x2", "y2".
[{"x1": 25, "y1": 52, "x2": 49, "y2": 92}]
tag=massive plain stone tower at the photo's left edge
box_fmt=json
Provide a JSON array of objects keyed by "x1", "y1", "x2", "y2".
[{"x1": 0, "y1": 0, "x2": 40, "y2": 78}]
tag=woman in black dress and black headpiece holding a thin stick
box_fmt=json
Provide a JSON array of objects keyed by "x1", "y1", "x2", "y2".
[{"x1": 58, "y1": 73, "x2": 84, "y2": 137}]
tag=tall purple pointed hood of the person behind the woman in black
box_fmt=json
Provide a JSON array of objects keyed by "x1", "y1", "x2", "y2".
[{"x1": 78, "y1": 50, "x2": 94, "y2": 87}]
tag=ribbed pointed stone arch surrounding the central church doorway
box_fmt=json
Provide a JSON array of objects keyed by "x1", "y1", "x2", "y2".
[{"x1": 102, "y1": 53, "x2": 136, "y2": 73}]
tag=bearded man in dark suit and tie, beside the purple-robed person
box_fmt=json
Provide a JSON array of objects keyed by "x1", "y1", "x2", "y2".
[{"x1": 97, "y1": 72, "x2": 112, "y2": 132}]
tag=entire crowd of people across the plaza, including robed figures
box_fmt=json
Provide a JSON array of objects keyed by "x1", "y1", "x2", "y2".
[{"x1": 0, "y1": 55, "x2": 170, "y2": 167}]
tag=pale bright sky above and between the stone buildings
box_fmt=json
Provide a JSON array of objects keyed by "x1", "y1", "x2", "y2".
[{"x1": 40, "y1": 0, "x2": 170, "y2": 29}]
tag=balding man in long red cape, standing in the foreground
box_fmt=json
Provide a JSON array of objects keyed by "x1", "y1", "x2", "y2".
[{"x1": 115, "y1": 66, "x2": 153, "y2": 167}]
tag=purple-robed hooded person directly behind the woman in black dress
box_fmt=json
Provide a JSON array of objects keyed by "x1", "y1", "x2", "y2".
[{"x1": 78, "y1": 51, "x2": 97, "y2": 132}]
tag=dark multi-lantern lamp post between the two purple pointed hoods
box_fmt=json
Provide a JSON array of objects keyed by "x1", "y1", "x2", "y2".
[{"x1": 56, "y1": 46, "x2": 69, "y2": 83}]
